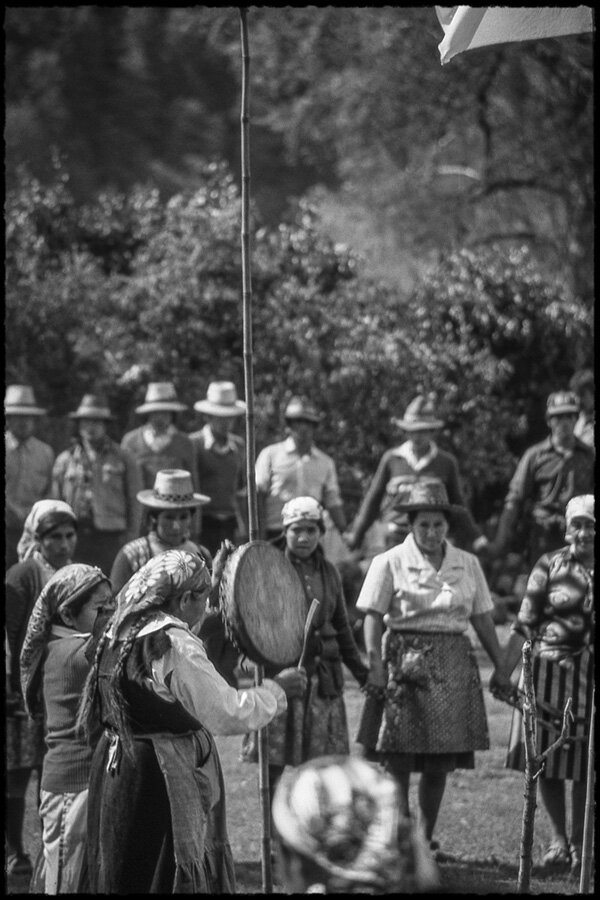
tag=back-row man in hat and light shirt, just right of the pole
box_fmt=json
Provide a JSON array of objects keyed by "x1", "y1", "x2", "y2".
[{"x1": 256, "y1": 397, "x2": 346, "y2": 540}]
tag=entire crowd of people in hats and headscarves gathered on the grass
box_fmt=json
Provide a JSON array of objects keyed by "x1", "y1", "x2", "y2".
[{"x1": 5, "y1": 370, "x2": 595, "y2": 894}]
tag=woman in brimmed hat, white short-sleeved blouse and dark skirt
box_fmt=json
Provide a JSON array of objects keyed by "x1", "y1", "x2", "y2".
[{"x1": 356, "y1": 481, "x2": 509, "y2": 849}]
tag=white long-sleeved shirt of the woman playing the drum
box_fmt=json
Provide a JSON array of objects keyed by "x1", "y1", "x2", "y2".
[{"x1": 131, "y1": 613, "x2": 287, "y2": 735}]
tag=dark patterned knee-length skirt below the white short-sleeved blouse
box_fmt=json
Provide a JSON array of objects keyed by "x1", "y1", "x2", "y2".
[{"x1": 357, "y1": 631, "x2": 489, "y2": 770}]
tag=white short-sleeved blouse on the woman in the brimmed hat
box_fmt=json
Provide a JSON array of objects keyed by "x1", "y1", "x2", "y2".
[{"x1": 356, "y1": 534, "x2": 494, "y2": 634}]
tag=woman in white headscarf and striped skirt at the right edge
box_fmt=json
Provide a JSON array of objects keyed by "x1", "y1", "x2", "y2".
[{"x1": 492, "y1": 494, "x2": 596, "y2": 875}]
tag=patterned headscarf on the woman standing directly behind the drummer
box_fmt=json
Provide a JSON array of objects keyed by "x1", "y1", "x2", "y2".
[{"x1": 20, "y1": 563, "x2": 110, "y2": 715}]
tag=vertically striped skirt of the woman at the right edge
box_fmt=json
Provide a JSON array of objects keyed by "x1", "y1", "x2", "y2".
[{"x1": 506, "y1": 649, "x2": 594, "y2": 781}]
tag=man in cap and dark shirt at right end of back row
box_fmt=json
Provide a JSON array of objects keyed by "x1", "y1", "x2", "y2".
[{"x1": 490, "y1": 391, "x2": 595, "y2": 567}]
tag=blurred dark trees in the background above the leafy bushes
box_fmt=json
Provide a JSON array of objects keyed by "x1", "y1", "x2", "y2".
[{"x1": 5, "y1": 6, "x2": 594, "y2": 309}]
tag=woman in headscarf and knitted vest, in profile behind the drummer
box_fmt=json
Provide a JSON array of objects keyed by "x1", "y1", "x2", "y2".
[{"x1": 21, "y1": 563, "x2": 112, "y2": 894}]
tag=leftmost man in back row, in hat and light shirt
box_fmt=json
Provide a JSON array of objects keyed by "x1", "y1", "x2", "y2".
[{"x1": 4, "y1": 384, "x2": 54, "y2": 570}]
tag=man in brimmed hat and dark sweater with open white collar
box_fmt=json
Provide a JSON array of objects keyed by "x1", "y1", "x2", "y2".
[{"x1": 347, "y1": 395, "x2": 488, "y2": 553}]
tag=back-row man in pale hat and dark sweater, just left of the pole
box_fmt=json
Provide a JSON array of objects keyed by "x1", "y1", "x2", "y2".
[{"x1": 190, "y1": 381, "x2": 247, "y2": 555}]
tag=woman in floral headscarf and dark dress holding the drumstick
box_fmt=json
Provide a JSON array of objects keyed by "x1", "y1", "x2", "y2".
[{"x1": 80, "y1": 550, "x2": 306, "y2": 894}]
